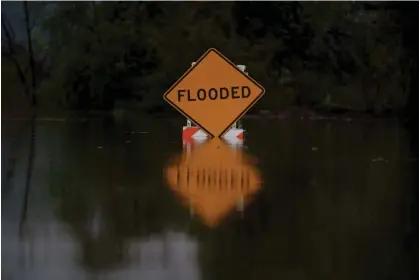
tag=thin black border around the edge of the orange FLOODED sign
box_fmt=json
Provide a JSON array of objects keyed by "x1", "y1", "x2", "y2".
[{"x1": 163, "y1": 48, "x2": 265, "y2": 138}]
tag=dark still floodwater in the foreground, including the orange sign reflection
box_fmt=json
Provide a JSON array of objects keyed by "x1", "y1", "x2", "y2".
[{"x1": 2, "y1": 117, "x2": 419, "y2": 280}]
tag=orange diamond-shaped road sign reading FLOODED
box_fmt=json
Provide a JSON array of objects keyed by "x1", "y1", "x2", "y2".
[{"x1": 164, "y1": 49, "x2": 265, "y2": 138}]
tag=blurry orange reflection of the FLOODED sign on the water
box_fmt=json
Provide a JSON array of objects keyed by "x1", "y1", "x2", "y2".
[{"x1": 166, "y1": 138, "x2": 262, "y2": 227}]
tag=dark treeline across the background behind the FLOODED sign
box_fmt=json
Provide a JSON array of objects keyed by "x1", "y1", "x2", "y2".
[{"x1": 2, "y1": 1, "x2": 418, "y2": 117}]
